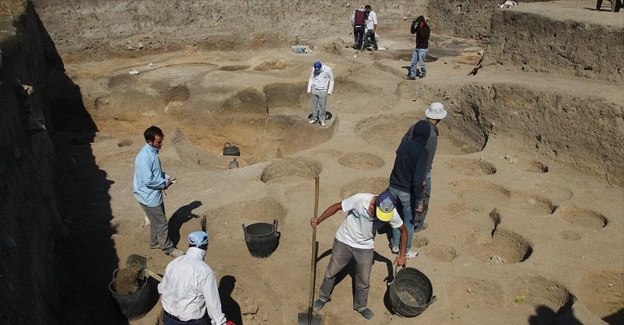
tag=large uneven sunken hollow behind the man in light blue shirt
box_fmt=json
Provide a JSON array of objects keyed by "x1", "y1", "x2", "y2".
[{"x1": 100, "y1": 63, "x2": 334, "y2": 169}]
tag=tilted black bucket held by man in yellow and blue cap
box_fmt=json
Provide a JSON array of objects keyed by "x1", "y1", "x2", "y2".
[{"x1": 388, "y1": 267, "x2": 436, "y2": 317}]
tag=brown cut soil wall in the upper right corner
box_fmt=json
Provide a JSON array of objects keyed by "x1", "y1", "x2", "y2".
[{"x1": 484, "y1": 10, "x2": 624, "y2": 83}]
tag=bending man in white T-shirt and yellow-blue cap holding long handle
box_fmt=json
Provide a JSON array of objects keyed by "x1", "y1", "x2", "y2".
[{"x1": 310, "y1": 192, "x2": 407, "y2": 319}]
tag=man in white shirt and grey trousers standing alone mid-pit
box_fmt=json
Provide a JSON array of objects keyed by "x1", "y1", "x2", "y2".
[{"x1": 308, "y1": 61, "x2": 334, "y2": 127}]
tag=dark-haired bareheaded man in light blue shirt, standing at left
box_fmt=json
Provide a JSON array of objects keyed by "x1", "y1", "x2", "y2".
[{"x1": 133, "y1": 125, "x2": 184, "y2": 257}]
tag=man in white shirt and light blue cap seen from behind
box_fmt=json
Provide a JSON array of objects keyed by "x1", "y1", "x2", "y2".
[{"x1": 158, "y1": 231, "x2": 235, "y2": 325}]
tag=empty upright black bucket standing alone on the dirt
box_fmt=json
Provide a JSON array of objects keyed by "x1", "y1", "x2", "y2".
[{"x1": 243, "y1": 220, "x2": 279, "y2": 258}]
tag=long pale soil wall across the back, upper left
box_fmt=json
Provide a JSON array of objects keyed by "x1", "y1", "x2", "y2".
[{"x1": 34, "y1": 0, "x2": 426, "y2": 62}]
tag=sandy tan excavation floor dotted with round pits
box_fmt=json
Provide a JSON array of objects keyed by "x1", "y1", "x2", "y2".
[{"x1": 47, "y1": 1, "x2": 624, "y2": 325}]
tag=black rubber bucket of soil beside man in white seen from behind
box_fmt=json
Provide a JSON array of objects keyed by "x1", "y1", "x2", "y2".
[{"x1": 108, "y1": 269, "x2": 154, "y2": 320}]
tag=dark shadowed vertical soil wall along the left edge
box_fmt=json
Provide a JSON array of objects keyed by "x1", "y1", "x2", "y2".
[{"x1": 0, "y1": 3, "x2": 63, "y2": 325}]
